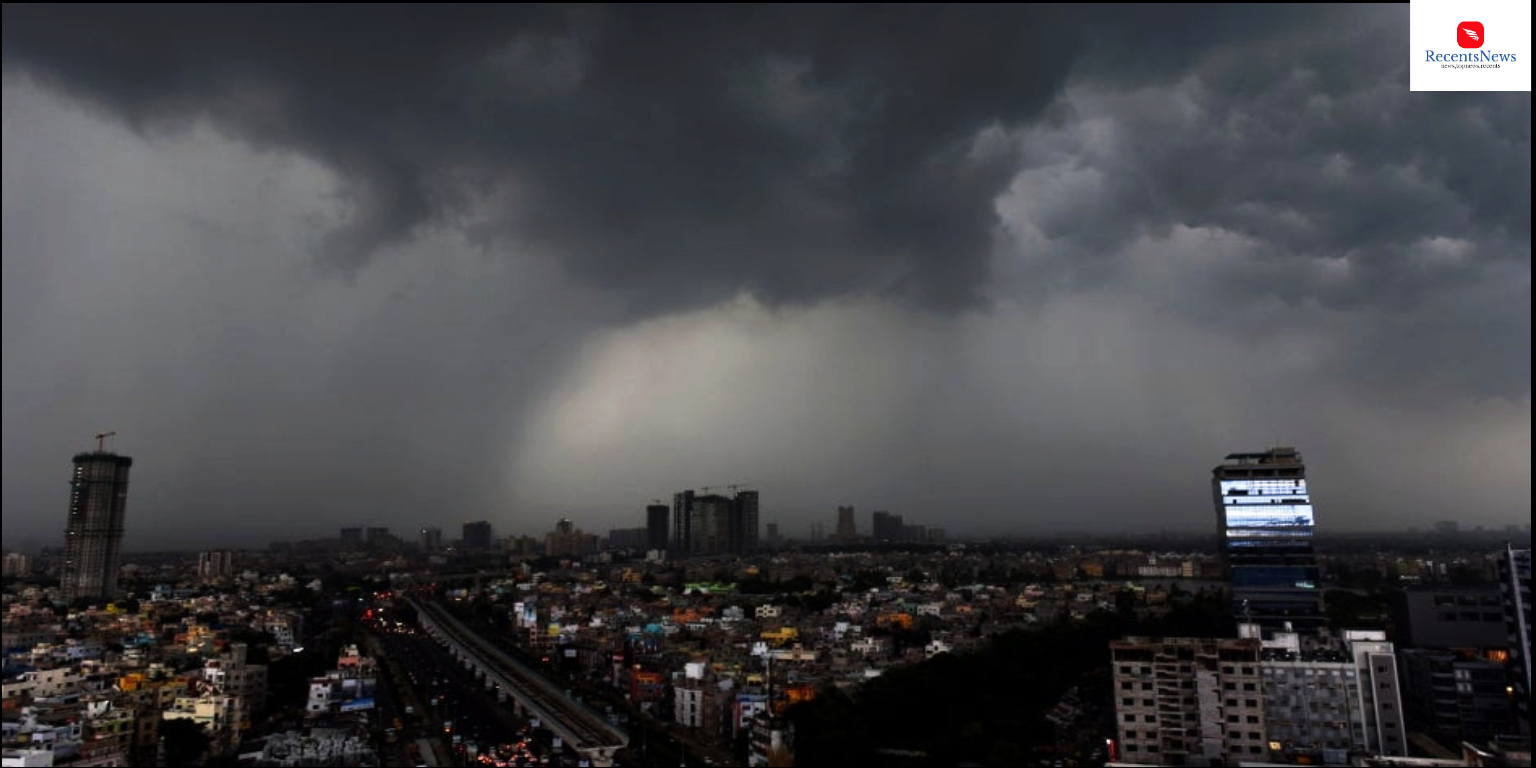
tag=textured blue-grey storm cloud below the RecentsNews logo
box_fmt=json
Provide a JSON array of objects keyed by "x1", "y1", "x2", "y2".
[{"x1": 995, "y1": 8, "x2": 1531, "y2": 398}]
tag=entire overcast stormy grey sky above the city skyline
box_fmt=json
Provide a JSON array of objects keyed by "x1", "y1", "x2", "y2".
[{"x1": 0, "y1": 5, "x2": 1531, "y2": 548}]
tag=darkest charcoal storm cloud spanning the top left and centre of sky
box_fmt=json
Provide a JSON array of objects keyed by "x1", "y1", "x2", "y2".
[{"x1": 5, "y1": 6, "x2": 1357, "y2": 310}]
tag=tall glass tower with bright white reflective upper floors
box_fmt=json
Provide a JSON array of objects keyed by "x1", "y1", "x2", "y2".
[{"x1": 1210, "y1": 447, "x2": 1324, "y2": 634}]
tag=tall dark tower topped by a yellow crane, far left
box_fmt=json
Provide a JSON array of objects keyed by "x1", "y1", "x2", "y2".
[{"x1": 60, "y1": 449, "x2": 134, "y2": 601}]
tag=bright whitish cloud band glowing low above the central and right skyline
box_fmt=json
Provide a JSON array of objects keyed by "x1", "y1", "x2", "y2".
[{"x1": 508, "y1": 289, "x2": 1530, "y2": 536}]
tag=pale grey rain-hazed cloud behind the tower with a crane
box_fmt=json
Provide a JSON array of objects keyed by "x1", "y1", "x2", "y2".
[{"x1": 3, "y1": 83, "x2": 602, "y2": 547}]
